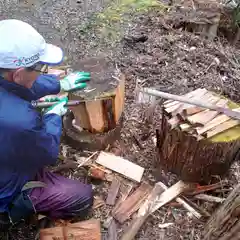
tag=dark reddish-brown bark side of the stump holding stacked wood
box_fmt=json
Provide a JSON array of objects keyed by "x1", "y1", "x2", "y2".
[{"x1": 157, "y1": 113, "x2": 240, "y2": 182}]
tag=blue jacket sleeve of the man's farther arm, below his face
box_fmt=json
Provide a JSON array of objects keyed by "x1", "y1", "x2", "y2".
[{"x1": 31, "y1": 74, "x2": 60, "y2": 100}]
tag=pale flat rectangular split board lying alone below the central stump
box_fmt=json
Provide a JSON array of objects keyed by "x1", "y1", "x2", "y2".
[{"x1": 96, "y1": 152, "x2": 144, "y2": 182}]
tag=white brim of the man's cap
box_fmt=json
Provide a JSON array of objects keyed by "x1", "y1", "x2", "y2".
[{"x1": 40, "y1": 44, "x2": 63, "y2": 65}]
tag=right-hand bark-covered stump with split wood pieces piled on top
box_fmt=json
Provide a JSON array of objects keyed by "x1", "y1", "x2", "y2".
[{"x1": 157, "y1": 89, "x2": 240, "y2": 183}]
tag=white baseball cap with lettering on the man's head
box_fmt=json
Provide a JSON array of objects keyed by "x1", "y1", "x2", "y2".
[{"x1": 0, "y1": 19, "x2": 63, "y2": 69}]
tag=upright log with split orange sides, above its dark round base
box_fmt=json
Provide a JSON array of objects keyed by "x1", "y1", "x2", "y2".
[{"x1": 69, "y1": 56, "x2": 125, "y2": 133}]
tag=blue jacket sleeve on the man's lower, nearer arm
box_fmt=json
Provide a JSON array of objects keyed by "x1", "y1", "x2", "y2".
[{"x1": 19, "y1": 110, "x2": 62, "y2": 169}]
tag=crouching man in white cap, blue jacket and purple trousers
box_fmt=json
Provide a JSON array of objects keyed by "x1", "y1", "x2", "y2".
[{"x1": 0, "y1": 19, "x2": 93, "y2": 227}]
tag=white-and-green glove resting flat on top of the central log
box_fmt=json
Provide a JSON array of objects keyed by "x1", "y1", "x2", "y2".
[{"x1": 60, "y1": 72, "x2": 90, "y2": 92}]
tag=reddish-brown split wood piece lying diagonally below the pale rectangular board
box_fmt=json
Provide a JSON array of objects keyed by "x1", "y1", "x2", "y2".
[{"x1": 112, "y1": 183, "x2": 152, "y2": 223}]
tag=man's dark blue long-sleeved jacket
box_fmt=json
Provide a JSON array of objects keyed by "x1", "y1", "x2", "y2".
[{"x1": 0, "y1": 75, "x2": 62, "y2": 212}]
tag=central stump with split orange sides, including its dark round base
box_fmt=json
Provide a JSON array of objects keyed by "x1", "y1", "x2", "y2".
[{"x1": 64, "y1": 56, "x2": 125, "y2": 150}]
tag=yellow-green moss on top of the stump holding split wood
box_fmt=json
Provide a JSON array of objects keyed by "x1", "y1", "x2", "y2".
[{"x1": 209, "y1": 93, "x2": 240, "y2": 142}]
